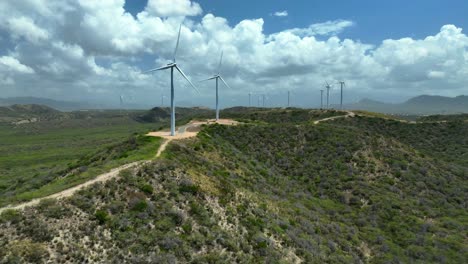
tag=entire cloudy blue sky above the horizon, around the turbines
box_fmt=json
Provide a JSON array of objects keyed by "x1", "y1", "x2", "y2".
[{"x1": 0, "y1": 0, "x2": 468, "y2": 107}]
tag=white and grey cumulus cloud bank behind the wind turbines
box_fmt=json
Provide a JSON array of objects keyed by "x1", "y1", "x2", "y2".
[{"x1": 0, "y1": 0, "x2": 468, "y2": 106}]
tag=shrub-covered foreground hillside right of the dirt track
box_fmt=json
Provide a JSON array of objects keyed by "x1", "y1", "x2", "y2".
[{"x1": 0, "y1": 110, "x2": 468, "y2": 263}]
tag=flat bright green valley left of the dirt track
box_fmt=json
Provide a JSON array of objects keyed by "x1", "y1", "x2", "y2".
[{"x1": 0, "y1": 108, "x2": 160, "y2": 206}]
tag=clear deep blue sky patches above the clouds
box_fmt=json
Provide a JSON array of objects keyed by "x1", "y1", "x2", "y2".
[{"x1": 125, "y1": 0, "x2": 468, "y2": 44}]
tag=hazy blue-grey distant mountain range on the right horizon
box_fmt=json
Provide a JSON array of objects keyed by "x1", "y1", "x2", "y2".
[{"x1": 346, "y1": 95, "x2": 468, "y2": 115}]
